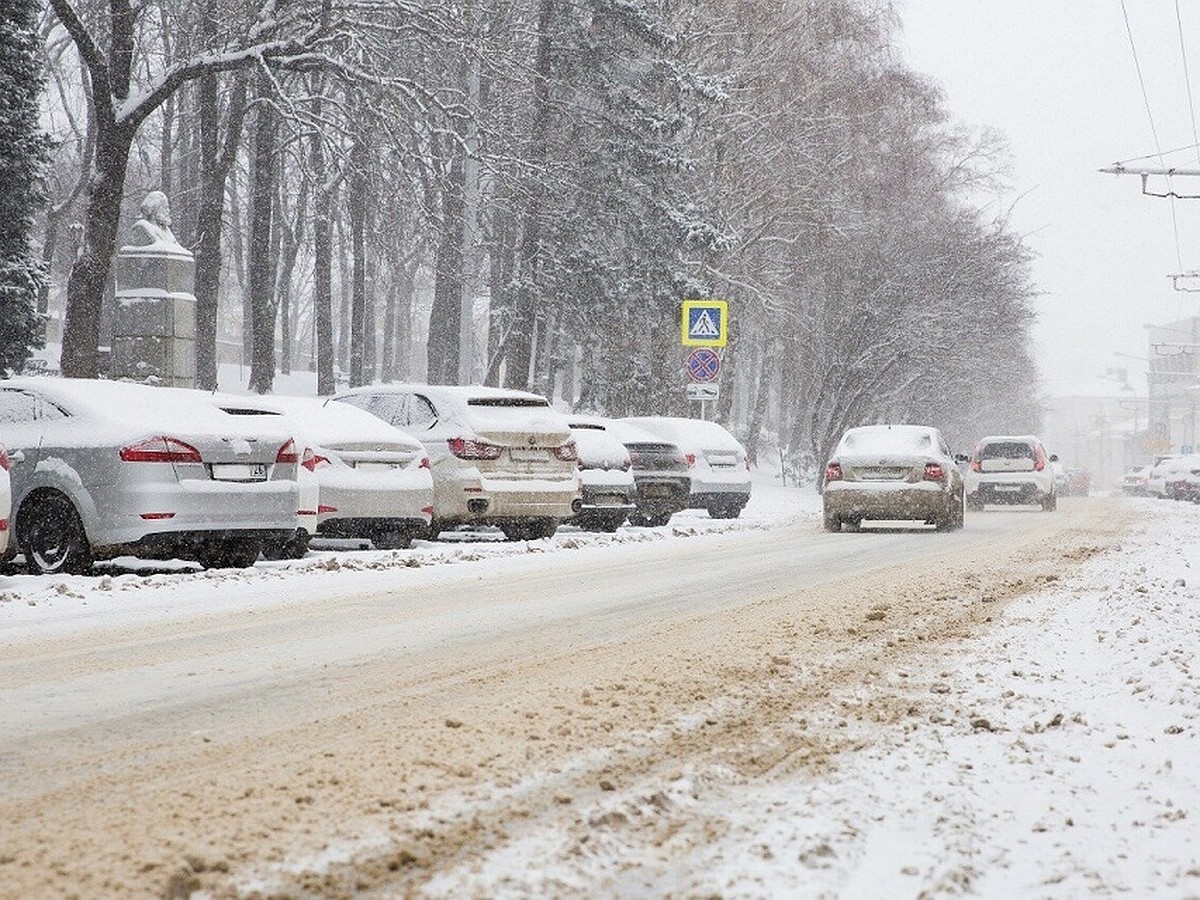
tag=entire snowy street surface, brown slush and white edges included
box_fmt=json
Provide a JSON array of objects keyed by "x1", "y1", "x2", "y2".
[{"x1": 0, "y1": 485, "x2": 1200, "y2": 896}]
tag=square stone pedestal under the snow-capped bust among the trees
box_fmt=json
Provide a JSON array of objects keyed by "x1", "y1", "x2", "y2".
[{"x1": 110, "y1": 241, "x2": 196, "y2": 388}]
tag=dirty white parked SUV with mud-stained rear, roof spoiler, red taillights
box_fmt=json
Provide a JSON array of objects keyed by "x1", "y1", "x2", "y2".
[{"x1": 330, "y1": 384, "x2": 583, "y2": 540}]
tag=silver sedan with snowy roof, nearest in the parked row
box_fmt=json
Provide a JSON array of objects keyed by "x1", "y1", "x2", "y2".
[{"x1": 0, "y1": 378, "x2": 299, "y2": 572}]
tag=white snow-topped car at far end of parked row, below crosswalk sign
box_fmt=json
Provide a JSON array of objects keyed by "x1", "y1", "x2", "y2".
[{"x1": 622, "y1": 415, "x2": 750, "y2": 518}]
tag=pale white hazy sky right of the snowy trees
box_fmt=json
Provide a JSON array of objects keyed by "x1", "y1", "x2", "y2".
[{"x1": 901, "y1": 0, "x2": 1200, "y2": 394}]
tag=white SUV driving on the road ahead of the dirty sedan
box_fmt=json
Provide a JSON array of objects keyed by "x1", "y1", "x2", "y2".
[{"x1": 965, "y1": 434, "x2": 1058, "y2": 512}]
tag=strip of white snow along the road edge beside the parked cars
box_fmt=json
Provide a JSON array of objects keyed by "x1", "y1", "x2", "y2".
[{"x1": 0, "y1": 469, "x2": 821, "y2": 641}]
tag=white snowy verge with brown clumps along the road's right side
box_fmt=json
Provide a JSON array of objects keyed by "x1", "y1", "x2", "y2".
[{"x1": 420, "y1": 502, "x2": 1200, "y2": 898}]
